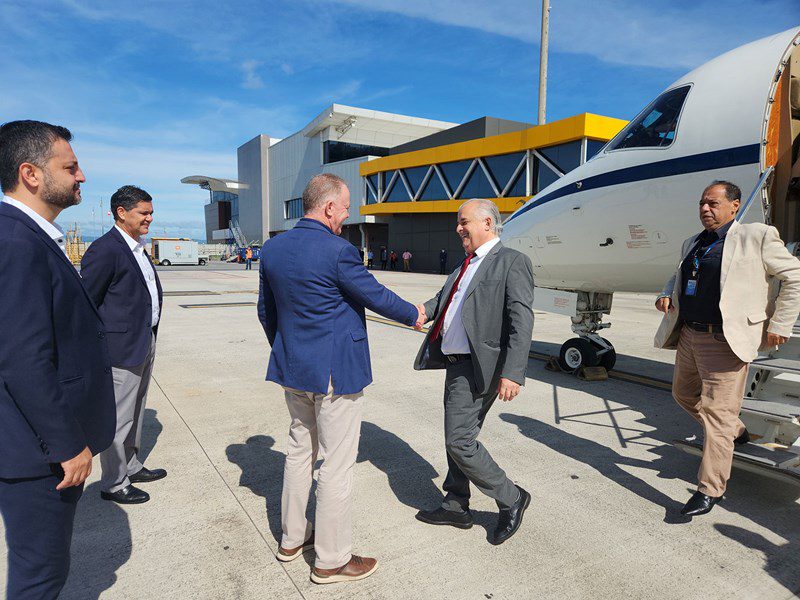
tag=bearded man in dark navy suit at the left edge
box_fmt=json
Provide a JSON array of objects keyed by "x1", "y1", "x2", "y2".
[{"x1": 0, "y1": 121, "x2": 114, "y2": 600}]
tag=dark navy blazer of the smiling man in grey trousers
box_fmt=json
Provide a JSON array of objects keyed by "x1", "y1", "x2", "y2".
[{"x1": 81, "y1": 227, "x2": 163, "y2": 368}]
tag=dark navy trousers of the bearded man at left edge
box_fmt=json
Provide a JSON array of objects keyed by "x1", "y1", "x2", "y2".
[{"x1": 0, "y1": 475, "x2": 83, "y2": 600}]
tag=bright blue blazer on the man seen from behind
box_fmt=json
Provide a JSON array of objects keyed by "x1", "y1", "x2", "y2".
[{"x1": 258, "y1": 219, "x2": 418, "y2": 394}]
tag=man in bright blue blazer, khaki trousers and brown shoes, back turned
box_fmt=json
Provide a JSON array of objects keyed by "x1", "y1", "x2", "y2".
[{"x1": 258, "y1": 173, "x2": 424, "y2": 583}]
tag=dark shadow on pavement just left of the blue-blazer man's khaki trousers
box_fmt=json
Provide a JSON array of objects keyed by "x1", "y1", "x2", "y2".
[{"x1": 225, "y1": 435, "x2": 288, "y2": 542}]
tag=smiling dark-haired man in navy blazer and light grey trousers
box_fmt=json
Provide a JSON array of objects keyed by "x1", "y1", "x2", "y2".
[{"x1": 81, "y1": 185, "x2": 167, "y2": 504}]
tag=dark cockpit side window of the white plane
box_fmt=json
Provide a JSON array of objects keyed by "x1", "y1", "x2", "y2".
[{"x1": 607, "y1": 85, "x2": 691, "y2": 152}]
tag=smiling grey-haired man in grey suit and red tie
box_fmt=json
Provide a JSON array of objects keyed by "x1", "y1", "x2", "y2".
[{"x1": 414, "y1": 199, "x2": 533, "y2": 544}]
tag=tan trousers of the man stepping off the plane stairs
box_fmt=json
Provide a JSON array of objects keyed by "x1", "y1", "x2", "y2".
[{"x1": 672, "y1": 326, "x2": 749, "y2": 498}]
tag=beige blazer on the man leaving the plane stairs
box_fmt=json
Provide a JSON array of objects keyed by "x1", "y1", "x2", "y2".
[{"x1": 654, "y1": 222, "x2": 800, "y2": 363}]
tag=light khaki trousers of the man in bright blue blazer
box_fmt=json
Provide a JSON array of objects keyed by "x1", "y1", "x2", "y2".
[{"x1": 281, "y1": 388, "x2": 363, "y2": 569}]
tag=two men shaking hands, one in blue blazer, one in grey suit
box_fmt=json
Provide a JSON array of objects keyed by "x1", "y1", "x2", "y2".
[{"x1": 258, "y1": 173, "x2": 533, "y2": 584}]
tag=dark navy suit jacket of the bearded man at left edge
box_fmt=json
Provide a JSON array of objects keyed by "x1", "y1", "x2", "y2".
[{"x1": 0, "y1": 203, "x2": 116, "y2": 478}]
